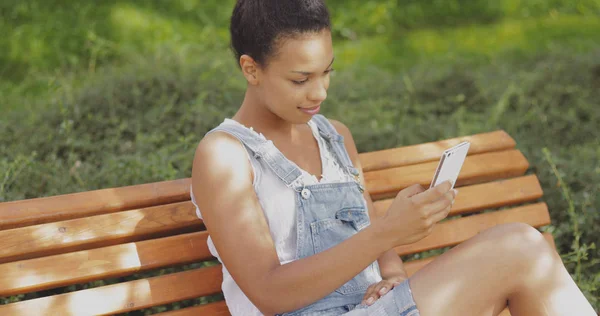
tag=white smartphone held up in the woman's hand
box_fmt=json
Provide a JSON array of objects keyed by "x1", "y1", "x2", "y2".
[{"x1": 429, "y1": 142, "x2": 471, "y2": 188}]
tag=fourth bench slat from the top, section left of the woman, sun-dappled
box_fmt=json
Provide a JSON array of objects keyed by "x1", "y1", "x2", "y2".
[{"x1": 0, "y1": 266, "x2": 223, "y2": 316}]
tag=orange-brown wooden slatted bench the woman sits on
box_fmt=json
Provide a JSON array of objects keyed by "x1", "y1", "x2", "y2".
[{"x1": 0, "y1": 131, "x2": 553, "y2": 316}]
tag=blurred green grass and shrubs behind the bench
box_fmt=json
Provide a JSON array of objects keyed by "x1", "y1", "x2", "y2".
[{"x1": 0, "y1": 0, "x2": 600, "y2": 315}]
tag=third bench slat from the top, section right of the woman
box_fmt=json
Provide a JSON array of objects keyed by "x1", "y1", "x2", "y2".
[{"x1": 373, "y1": 175, "x2": 543, "y2": 216}]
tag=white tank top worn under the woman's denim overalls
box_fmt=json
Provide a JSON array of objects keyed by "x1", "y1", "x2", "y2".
[{"x1": 190, "y1": 119, "x2": 354, "y2": 316}]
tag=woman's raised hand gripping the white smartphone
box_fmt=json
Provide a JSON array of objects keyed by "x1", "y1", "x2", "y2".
[{"x1": 378, "y1": 181, "x2": 458, "y2": 247}]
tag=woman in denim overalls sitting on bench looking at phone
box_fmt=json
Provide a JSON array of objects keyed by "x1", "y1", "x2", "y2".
[{"x1": 191, "y1": 0, "x2": 595, "y2": 316}]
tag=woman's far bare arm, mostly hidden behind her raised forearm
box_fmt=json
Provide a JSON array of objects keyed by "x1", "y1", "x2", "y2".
[{"x1": 330, "y1": 120, "x2": 408, "y2": 280}]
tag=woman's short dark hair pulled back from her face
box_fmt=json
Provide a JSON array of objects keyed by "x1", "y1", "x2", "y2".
[{"x1": 229, "y1": 0, "x2": 331, "y2": 67}]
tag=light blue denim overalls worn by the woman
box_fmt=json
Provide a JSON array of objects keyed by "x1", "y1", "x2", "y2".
[{"x1": 209, "y1": 115, "x2": 381, "y2": 316}]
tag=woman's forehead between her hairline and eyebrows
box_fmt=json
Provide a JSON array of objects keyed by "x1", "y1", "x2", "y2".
[{"x1": 270, "y1": 31, "x2": 333, "y2": 71}]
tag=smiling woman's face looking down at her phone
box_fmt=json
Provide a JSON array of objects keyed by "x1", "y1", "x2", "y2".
[{"x1": 242, "y1": 30, "x2": 334, "y2": 124}]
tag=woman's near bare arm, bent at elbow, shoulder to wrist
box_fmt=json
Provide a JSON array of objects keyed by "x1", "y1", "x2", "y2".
[{"x1": 192, "y1": 133, "x2": 392, "y2": 315}]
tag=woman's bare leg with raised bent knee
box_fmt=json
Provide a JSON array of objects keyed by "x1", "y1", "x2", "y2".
[{"x1": 409, "y1": 223, "x2": 596, "y2": 316}]
